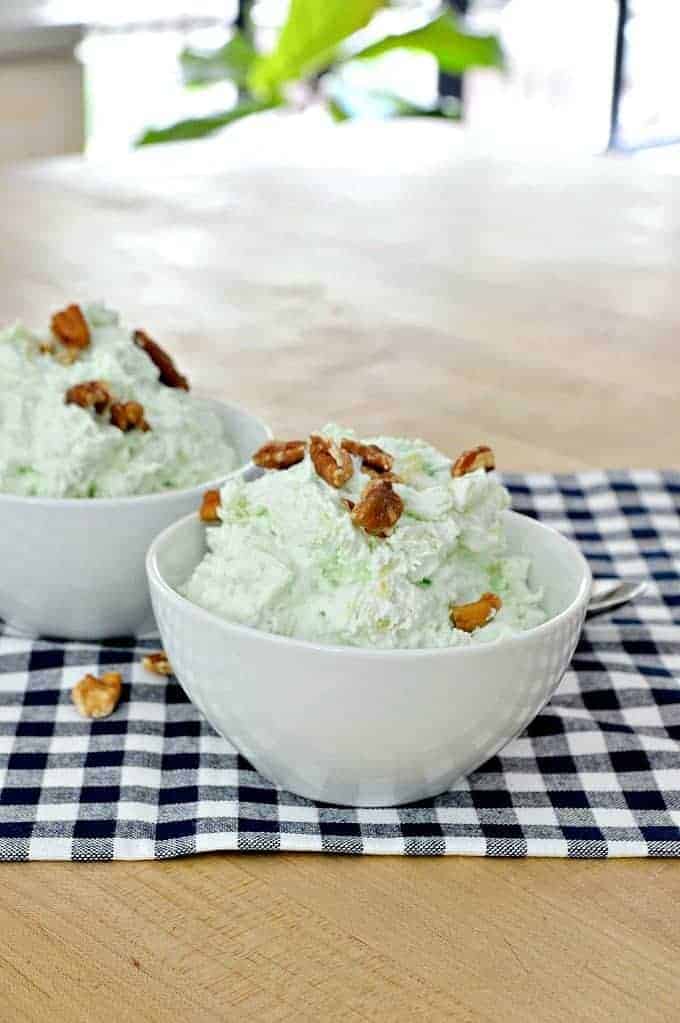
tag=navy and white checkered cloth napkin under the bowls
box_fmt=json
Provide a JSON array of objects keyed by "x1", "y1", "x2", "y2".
[{"x1": 0, "y1": 472, "x2": 680, "y2": 860}]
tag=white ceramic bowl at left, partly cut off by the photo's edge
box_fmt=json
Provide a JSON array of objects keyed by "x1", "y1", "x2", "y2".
[{"x1": 0, "y1": 399, "x2": 271, "y2": 639}]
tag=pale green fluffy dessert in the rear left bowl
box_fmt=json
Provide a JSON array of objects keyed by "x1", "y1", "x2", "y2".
[{"x1": 0, "y1": 305, "x2": 236, "y2": 497}]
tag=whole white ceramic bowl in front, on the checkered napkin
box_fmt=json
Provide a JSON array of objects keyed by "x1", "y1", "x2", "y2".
[{"x1": 146, "y1": 512, "x2": 591, "y2": 806}]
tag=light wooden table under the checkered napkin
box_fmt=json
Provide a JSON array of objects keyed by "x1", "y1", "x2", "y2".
[{"x1": 0, "y1": 124, "x2": 680, "y2": 1023}]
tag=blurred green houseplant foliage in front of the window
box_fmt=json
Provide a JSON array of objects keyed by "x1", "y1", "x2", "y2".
[{"x1": 138, "y1": 0, "x2": 502, "y2": 145}]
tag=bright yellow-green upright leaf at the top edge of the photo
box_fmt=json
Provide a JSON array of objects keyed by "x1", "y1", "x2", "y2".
[{"x1": 248, "y1": 0, "x2": 386, "y2": 97}]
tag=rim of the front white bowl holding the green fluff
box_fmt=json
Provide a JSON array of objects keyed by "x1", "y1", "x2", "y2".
[{"x1": 145, "y1": 508, "x2": 592, "y2": 660}]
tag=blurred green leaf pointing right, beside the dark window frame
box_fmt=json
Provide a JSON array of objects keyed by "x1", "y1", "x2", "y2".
[{"x1": 353, "y1": 13, "x2": 503, "y2": 75}]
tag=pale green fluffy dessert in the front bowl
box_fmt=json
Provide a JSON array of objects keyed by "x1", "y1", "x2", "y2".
[{"x1": 182, "y1": 426, "x2": 546, "y2": 649}]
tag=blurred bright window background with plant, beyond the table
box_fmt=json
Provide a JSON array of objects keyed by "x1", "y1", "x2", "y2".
[{"x1": 0, "y1": 0, "x2": 680, "y2": 168}]
